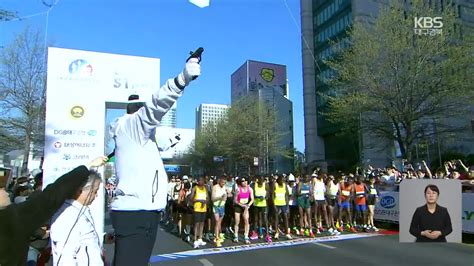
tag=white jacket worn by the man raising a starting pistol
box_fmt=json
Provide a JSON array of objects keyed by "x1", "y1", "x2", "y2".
[{"x1": 110, "y1": 79, "x2": 183, "y2": 211}]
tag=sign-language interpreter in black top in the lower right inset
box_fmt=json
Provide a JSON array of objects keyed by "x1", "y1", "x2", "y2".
[{"x1": 410, "y1": 185, "x2": 453, "y2": 242}]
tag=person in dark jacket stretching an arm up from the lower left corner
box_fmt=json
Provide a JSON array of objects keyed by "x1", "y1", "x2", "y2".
[{"x1": 0, "y1": 156, "x2": 107, "y2": 266}]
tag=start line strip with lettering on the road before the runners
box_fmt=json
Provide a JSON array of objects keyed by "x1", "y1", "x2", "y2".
[{"x1": 150, "y1": 233, "x2": 382, "y2": 263}]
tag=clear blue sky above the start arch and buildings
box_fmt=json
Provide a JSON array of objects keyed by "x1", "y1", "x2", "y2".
[{"x1": 0, "y1": 0, "x2": 304, "y2": 151}]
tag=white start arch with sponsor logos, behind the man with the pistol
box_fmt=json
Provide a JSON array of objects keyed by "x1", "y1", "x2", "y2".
[{"x1": 43, "y1": 47, "x2": 160, "y2": 239}]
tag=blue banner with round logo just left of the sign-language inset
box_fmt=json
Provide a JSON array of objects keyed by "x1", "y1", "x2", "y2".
[{"x1": 374, "y1": 191, "x2": 400, "y2": 223}]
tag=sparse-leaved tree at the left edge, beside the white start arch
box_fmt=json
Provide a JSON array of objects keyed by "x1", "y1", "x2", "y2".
[{"x1": 0, "y1": 28, "x2": 46, "y2": 173}]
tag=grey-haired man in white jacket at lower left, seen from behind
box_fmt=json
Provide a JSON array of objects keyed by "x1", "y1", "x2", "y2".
[{"x1": 50, "y1": 171, "x2": 104, "y2": 266}]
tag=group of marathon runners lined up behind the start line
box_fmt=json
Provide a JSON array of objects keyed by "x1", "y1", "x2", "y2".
[{"x1": 168, "y1": 173, "x2": 379, "y2": 248}]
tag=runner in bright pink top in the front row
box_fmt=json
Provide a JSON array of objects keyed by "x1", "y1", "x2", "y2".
[{"x1": 234, "y1": 177, "x2": 254, "y2": 244}]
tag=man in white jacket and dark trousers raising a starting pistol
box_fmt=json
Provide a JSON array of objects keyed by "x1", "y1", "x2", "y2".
[{"x1": 110, "y1": 55, "x2": 201, "y2": 266}]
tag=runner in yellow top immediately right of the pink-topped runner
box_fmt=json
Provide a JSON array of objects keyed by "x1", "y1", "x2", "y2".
[{"x1": 250, "y1": 176, "x2": 272, "y2": 243}]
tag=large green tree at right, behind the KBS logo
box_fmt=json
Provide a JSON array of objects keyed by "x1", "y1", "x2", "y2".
[{"x1": 321, "y1": 0, "x2": 474, "y2": 159}]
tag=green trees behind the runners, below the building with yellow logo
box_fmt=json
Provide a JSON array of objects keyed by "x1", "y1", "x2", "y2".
[{"x1": 188, "y1": 96, "x2": 294, "y2": 174}]
